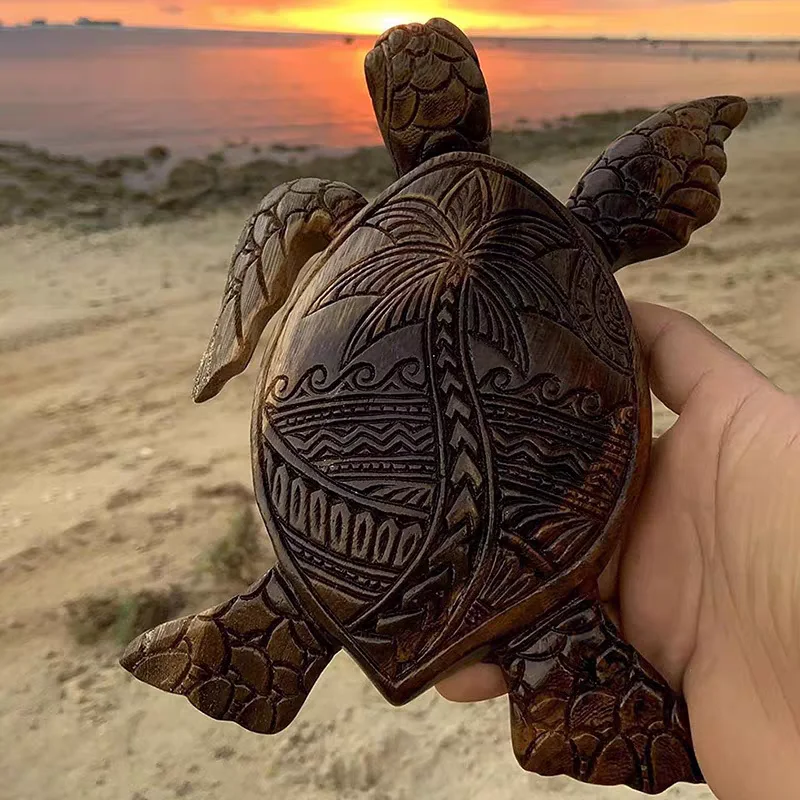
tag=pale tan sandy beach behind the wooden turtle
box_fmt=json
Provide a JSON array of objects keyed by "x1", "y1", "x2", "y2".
[{"x1": 0, "y1": 99, "x2": 800, "y2": 800}]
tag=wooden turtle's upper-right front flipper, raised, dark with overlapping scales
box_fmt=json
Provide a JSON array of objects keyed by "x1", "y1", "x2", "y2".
[{"x1": 567, "y1": 97, "x2": 747, "y2": 270}]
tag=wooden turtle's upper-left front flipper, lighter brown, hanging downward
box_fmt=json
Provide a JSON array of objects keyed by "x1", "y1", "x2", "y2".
[{"x1": 193, "y1": 178, "x2": 367, "y2": 403}]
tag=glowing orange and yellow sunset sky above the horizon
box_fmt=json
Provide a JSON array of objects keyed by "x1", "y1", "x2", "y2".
[{"x1": 0, "y1": 0, "x2": 800, "y2": 38}]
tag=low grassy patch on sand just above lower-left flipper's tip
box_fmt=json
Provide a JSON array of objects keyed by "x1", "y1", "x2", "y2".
[{"x1": 66, "y1": 586, "x2": 186, "y2": 647}]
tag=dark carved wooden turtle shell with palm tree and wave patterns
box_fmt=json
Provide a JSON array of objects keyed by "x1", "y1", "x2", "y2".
[{"x1": 252, "y1": 153, "x2": 650, "y2": 703}]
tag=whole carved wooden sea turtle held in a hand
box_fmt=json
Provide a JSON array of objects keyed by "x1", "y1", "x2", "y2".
[{"x1": 122, "y1": 19, "x2": 747, "y2": 793}]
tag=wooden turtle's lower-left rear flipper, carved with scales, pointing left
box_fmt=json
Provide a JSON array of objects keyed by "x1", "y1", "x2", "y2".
[{"x1": 120, "y1": 569, "x2": 339, "y2": 733}]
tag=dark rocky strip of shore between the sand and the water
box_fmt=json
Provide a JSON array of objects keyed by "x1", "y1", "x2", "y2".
[{"x1": 0, "y1": 96, "x2": 785, "y2": 232}]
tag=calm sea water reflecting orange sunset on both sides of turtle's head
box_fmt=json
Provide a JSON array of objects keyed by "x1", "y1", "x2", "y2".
[{"x1": 0, "y1": 28, "x2": 800, "y2": 157}]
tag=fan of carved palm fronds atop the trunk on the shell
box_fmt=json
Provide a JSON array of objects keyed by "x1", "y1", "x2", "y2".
[{"x1": 309, "y1": 170, "x2": 574, "y2": 372}]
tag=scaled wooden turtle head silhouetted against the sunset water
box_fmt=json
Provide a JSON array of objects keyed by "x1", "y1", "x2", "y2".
[{"x1": 364, "y1": 19, "x2": 492, "y2": 180}]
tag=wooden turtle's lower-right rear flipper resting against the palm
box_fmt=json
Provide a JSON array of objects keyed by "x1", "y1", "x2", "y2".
[{"x1": 495, "y1": 596, "x2": 704, "y2": 794}]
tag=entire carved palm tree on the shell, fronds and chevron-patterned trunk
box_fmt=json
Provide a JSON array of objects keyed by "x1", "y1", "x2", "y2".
[{"x1": 309, "y1": 168, "x2": 574, "y2": 655}]
